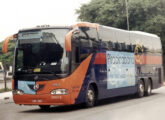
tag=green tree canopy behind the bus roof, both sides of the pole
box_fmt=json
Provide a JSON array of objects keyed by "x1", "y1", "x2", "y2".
[{"x1": 76, "y1": 0, "x2": 165, "y2": 60}]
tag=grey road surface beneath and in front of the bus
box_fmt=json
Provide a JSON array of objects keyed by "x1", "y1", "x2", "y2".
[{"x1": 0, "y1": 87, "x2": 165, "y2": 120}]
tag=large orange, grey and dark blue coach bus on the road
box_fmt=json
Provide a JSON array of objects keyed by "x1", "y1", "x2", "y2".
[{"x1": 3, "y1": 22, "x2": 163, "y2": 109}]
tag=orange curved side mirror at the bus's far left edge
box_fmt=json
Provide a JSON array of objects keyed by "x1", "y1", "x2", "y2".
[{"x1": 2, "y1": 34, "x2": 17, "y2": 54}]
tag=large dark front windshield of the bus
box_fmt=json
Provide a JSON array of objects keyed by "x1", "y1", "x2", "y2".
[{"x1": 15, "y1": 29, "x2": 69, "y2": 74}]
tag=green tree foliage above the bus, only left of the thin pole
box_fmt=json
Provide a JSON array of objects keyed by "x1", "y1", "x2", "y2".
[{"x1": 76, "y1": 0, "x2": 127, "y2": 29}]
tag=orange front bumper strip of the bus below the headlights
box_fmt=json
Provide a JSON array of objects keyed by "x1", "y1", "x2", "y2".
[{"x1": 13, "y1": 94, "x2": 71, "y2": 105}]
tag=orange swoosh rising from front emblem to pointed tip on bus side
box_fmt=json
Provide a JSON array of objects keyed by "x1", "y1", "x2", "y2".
[{"x1": 36, "y1": 54, "x2": 92, "y2": 104}]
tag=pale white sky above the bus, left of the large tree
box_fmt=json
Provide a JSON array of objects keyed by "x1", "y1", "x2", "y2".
[{"x1": 0, "y1": 0, "x2": 90, "y2": 41}]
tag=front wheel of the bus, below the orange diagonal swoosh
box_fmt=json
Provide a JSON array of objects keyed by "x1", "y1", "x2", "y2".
[{"x1": 85, "y1": 86, "x2": 96, "y2": 107}]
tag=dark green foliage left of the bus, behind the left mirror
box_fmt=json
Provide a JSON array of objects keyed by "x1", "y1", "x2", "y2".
[{"x1": 0, "y1": 41, "x2": 15, "y2": 66}]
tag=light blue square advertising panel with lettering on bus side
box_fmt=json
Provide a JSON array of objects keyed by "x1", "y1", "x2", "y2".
[{"x1": 106, "y1": 51, "x2": 135, "y2": 89}]
